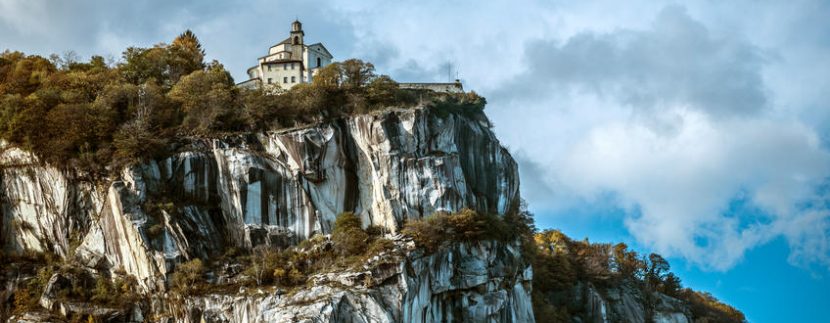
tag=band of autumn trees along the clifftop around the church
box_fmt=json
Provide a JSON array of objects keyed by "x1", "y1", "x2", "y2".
[{"x1": 0, "y1": 31, "x2": 484, "y2": 176}]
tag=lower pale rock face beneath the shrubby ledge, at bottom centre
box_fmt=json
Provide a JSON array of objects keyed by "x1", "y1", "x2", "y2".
[{"x1": 164, "y1": 238, "x2": 534, "y2": 323}]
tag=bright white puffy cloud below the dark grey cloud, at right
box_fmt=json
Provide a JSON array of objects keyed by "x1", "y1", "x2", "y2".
[{"x1": 558, "y1": 108, "x2": 830, "y2": 270}]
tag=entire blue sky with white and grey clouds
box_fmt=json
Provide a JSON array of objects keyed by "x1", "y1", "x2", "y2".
[{"x1": 0, "y1": 0, "x2": 830, "y2": 322}]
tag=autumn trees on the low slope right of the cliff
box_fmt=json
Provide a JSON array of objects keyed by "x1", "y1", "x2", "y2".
[{"x1": 532, "y1": 230, "x2": 746, "y2": 322}]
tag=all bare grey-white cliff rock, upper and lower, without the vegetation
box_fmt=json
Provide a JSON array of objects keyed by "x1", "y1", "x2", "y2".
[{"x1": 0, "y1": 107, "x2": 704, "y2": 322}]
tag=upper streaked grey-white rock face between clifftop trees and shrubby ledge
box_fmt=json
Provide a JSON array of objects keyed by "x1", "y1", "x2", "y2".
[{"x1": 0, "y1": 109, "x2": 519, "y2": 290}]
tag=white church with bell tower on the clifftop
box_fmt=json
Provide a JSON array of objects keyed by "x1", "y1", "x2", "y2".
[{"x1": 239, "y1": 21, "x2": 334, "y2": 90}]
